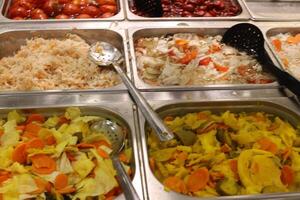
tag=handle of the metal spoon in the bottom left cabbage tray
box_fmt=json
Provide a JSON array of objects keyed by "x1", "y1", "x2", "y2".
[{"x1": 111, "y1": 156, "x2": 140, "y2": 200}]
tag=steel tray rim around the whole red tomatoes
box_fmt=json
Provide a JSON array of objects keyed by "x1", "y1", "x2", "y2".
[{"x1": 0, "y1": 0, "x2": 125, "y2": 23}]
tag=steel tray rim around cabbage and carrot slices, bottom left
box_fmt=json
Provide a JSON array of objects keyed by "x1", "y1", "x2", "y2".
[{"x1": 0, "y1": 94, "x2": 144, "y2": 200}]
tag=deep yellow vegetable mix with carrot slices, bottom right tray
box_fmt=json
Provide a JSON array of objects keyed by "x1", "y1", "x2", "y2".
[{"x1": 147, "y1": 111, "x2": 300, "y2": 197}]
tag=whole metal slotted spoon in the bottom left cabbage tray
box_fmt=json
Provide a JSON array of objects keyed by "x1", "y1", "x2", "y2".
[{"x1": 91, "y1": 120, "x2": 140, "y2": 200}]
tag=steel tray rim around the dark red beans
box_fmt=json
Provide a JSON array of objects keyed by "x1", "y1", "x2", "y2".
[{"x1": 124, "y1": 0, "x2": 250, "y2": 21}]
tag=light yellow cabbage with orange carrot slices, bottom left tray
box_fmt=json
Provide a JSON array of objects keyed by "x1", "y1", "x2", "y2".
[{"x1": 0, "y1": 107, "x2": 132, "y2": 200}]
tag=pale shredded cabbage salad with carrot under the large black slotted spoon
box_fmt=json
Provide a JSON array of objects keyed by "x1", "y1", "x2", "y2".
[{"x1": 135, "y1": 33, "x2": 274, "y2": 85}]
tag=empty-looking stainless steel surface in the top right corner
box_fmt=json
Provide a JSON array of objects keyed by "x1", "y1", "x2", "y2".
[{"x1": 243, "y1": 0, "x2": 300, "y2": 21}]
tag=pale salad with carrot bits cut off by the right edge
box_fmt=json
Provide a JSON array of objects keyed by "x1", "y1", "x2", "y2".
[{"x1": 271, "y1": 33, "x2": 300, "y2": 79}]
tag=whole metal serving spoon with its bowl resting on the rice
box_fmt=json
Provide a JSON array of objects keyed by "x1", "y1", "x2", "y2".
[{"x1": 89, "y1": 42, "x2": 174, "y2": 141}]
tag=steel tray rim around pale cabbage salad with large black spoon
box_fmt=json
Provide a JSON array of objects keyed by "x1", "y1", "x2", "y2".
[{"x1": 128, "y1": 26, "x2": 279, "y2": 91}]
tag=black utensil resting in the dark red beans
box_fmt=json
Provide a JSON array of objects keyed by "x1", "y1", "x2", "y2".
[{"x1": 134, "y1": 0, "x2": 163, "y2": 17}]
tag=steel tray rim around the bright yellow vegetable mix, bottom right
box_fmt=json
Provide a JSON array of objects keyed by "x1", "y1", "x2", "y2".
[{"x1": 140, "y1": 98, "x2": 300, "y2": 200}]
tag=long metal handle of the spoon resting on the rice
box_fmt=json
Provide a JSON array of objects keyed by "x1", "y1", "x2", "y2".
[{"x1": 114, "y1": 64, "x2": 174, "y2": 141}]
